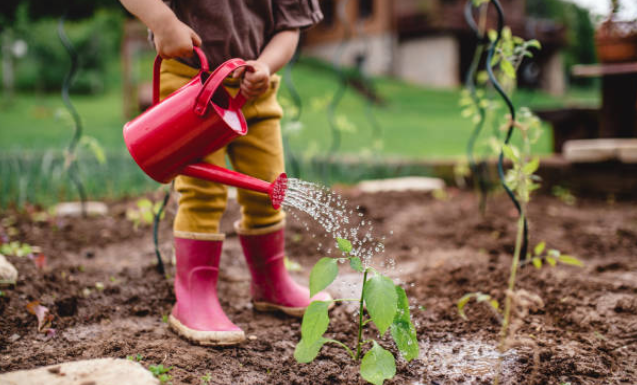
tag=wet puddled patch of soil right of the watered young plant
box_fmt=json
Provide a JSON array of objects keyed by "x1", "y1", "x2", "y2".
[{"x1": 412, "y1": 339, "x2": 517, "y2": 385}]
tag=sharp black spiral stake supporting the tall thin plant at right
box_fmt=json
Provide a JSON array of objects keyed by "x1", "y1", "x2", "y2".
[{"x1": 487, "y1": 0, "x2": 529, "y2": 259}]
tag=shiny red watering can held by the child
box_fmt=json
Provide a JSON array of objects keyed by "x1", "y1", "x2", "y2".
[{"x1": 124, "y1": 47, "x2": 287, "y2": 209}]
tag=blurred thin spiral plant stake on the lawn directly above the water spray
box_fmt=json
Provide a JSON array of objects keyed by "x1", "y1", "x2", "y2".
[{"x1": 323, "y1": 0, "x2": 352, "y2": 185}]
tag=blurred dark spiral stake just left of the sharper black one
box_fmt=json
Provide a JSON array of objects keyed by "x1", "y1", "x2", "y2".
[{"x1": 464, "y1": 0, "x2": 489, "y2": 213}]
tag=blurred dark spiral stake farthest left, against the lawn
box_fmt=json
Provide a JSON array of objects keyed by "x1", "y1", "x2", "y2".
[{"x1": 57, "y1": 14, "x2": 87, "y2": 217}]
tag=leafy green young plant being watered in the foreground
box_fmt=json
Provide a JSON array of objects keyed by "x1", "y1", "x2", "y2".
[{"x1": 294, "y1": 238, "x2": 419, "y2": 385}]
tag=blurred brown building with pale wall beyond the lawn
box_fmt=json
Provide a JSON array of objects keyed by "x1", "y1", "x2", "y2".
[{"x1": 303, "y1": 0, "x2": 566, "y2": 95}]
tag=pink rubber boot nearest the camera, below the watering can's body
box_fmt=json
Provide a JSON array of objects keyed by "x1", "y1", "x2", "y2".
[{"x1": 168, "y1": 231, "x2": 245, "y2": 345}]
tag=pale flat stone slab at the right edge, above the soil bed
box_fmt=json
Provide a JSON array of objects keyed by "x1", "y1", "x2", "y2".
[{"x1": 562, "y1": 139, "x2": 637, "y2": 163}]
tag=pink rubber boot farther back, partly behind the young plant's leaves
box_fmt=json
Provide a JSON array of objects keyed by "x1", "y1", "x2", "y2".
[{"x1": 235, "y1": 221, "x2": 332, "y2": 317}]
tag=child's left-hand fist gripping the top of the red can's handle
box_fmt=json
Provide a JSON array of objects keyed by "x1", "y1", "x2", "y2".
[{"x1": 153, "y1": 17, "x2": 201, "y2": 59}]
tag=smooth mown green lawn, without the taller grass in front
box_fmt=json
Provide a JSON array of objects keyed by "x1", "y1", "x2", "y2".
[{"x1": 0, "y1": 57, "x2": 598, "y2": 157}]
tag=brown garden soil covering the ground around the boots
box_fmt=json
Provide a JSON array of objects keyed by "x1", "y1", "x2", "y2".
[{"x1": 0, "y1": 190, "x2": 637, "y2": 385}]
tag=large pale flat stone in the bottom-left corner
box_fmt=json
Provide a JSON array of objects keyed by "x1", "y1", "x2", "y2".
[{"x1": 0, "y1": 358, "x2": 159, "y2": 385}]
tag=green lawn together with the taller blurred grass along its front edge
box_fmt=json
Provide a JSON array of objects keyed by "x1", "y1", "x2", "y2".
[{"x1": 0, "y1": 58, "x2": 599, "y2": 207}]
